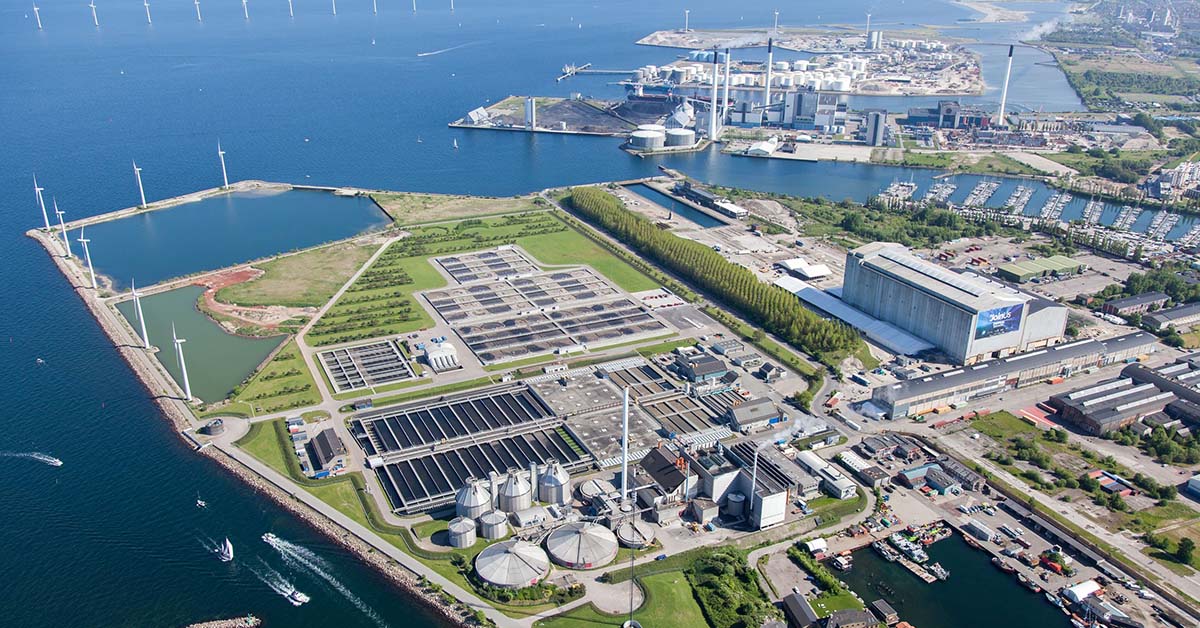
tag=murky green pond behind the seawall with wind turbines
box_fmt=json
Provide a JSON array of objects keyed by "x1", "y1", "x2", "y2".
[{"x1": 116, "y1": 286, "x2": 283, "y2": 402}]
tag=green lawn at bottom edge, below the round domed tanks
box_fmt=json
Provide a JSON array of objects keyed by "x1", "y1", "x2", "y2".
[{"x1": 535, "y1": 572, "x2": 707, "y2": 628}]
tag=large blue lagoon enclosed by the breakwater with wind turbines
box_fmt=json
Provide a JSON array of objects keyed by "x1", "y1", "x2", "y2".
[{"x1": 90, "y1": 190, "x2": 389, "y2": 288}]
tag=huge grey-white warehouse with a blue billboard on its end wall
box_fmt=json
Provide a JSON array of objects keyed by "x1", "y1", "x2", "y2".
[{"x1": 842, "y1": 243, "x2": 1067, "y2": 364}]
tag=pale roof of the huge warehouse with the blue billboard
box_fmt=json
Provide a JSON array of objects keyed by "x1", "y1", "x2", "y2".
[{"x1": 851, "y1": 243, "x2": 1028, "y2": 313}]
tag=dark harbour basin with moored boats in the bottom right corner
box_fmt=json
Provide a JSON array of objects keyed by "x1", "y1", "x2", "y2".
[{"x1": 839, "y1": 536, "x2": 1070, "y2": 628}]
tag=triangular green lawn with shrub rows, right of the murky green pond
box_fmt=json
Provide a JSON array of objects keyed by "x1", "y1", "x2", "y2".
[{"x1": 223, "y1": 340, "x2": 320, "y2": 414}]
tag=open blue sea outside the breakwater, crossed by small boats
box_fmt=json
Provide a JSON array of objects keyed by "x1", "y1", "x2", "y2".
[{"x1": 0, "y1": 0, "x2": 1089, "y2": 627}]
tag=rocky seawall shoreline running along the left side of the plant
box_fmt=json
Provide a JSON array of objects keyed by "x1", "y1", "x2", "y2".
[{"x1": 26, "y1": 229, "x2": 478, "y2": 628}]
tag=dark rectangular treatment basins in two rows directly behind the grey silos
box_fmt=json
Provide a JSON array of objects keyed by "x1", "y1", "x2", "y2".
[{"x1": 350, "y1": 384, "x2": 593, "y2": 514}]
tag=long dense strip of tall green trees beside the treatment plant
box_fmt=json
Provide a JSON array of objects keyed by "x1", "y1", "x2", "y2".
[{"x1": 566, "y1": 187, "x2": 860, "y2": 355}]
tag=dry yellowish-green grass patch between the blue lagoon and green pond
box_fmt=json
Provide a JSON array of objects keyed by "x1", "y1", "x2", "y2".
[{"x1": 216, "y1": 243, "x2": 376, "y2": 307}]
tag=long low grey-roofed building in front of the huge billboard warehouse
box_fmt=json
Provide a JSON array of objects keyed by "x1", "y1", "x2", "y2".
[{"x1": 871, "y1": 331, "x2": 1159, "y2": 419}]
